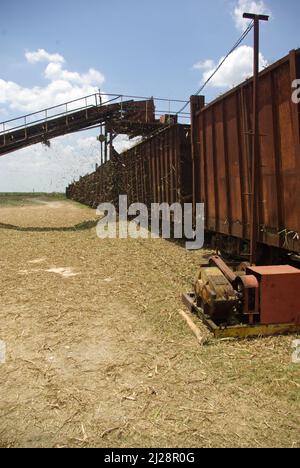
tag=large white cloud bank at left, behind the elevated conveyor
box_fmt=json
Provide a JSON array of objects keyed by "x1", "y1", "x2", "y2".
[{"x1": 0, "y1": 49, "x2": 108, "y2": 191}]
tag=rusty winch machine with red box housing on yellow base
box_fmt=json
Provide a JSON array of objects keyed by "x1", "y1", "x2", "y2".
[{"x1": 183, "y1": 256, "x2": 300, "y2": 338}]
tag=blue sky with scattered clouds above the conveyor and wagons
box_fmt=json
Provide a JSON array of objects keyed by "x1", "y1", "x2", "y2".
[{"x1": 0, "y1": 0, "x2": 300, "y2": 191}]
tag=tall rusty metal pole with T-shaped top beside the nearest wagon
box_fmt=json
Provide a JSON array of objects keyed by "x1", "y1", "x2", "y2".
[{"x1": 243, "y1": 13, "x2": 269, "y2": 265}]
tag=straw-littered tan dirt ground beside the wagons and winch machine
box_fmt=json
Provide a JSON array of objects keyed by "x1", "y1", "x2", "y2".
[{"x1": 0, "y1": 198, "x2": 300, "y2": 447}]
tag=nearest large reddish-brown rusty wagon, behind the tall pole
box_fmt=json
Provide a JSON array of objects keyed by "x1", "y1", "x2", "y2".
[{"x1": 191, "y1": 49, "x2": 300, "y2": 261}]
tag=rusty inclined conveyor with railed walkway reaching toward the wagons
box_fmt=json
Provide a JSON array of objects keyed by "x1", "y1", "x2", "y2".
[{"x1": 0, "y1": 93, "x2": 189, "y2": 156}]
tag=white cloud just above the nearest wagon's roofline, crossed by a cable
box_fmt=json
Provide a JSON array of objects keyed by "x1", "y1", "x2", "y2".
[{"x1": 194, "y1": 45, "x2": 268, "y2": 88}]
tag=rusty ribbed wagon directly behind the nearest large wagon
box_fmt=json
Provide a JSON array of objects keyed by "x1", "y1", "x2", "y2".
[{"x1": 121, "y1": 124, "x2": 192, "y2": 208}]
